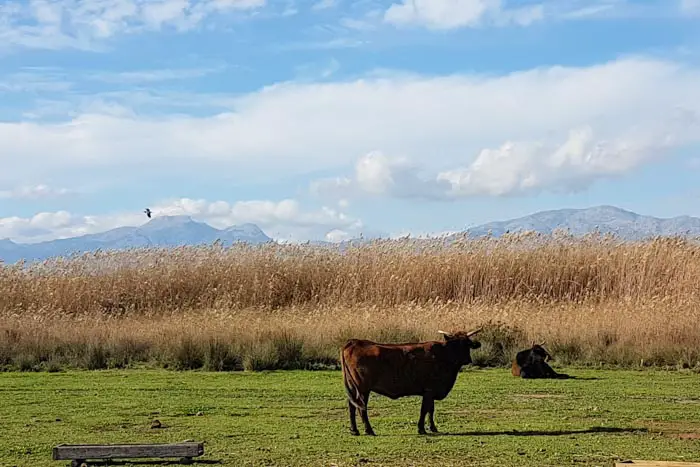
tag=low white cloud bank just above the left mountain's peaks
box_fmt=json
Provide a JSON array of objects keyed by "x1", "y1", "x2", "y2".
[{"x1": 0, "y1": 198, "x2": 362, "y2": 242}]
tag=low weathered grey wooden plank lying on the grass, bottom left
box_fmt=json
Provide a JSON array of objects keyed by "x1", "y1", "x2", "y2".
[{"x1": 53, "y1": 443, "x2": 204, "y2": 460}]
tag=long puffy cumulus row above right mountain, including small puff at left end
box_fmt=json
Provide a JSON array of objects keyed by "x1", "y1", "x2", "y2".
[{"x1": 311, "y1": 111, "x2": 700, "y2": 200}]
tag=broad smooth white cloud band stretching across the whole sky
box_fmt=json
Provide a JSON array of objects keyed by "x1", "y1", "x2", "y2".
[{"x1": 0, "y1": 58, "x2": 700, "y2": 191}]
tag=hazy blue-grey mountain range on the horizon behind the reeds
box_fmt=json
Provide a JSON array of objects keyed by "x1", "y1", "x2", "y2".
[{"x1": 0, "y1": 206, "x2": 700, "y2": 264}]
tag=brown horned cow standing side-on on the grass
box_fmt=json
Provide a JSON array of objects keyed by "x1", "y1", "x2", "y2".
[{"x1": 340, "y1": 329, "x2": 481, "y2": 436}]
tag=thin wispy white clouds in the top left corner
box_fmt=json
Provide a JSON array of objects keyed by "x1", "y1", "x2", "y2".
[{"x1": 0, "y1": 0, "x2": 265, "y2": 50}]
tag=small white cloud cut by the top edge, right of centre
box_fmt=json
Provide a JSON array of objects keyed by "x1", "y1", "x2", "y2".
[{"x1": 384, "y1": 0, "x2": 544, "y2": 29}]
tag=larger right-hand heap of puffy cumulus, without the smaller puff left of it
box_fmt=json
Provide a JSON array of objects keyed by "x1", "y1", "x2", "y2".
[{"x1": 437, "y1": 119, "x2": 700, "y2": 197}]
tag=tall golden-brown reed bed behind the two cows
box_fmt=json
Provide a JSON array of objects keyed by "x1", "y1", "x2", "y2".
[{"x1": 0, "y1": 233, "x2": 700, "y2": 371}]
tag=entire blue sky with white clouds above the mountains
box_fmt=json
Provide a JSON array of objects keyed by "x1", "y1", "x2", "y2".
[{"x1": 0, "y1": 0, "x2": 700, "y2": 242}]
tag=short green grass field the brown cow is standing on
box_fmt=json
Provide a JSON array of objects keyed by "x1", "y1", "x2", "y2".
[{"x1": 0, "y1": 369, "x2": 700, "y2": 466}]
